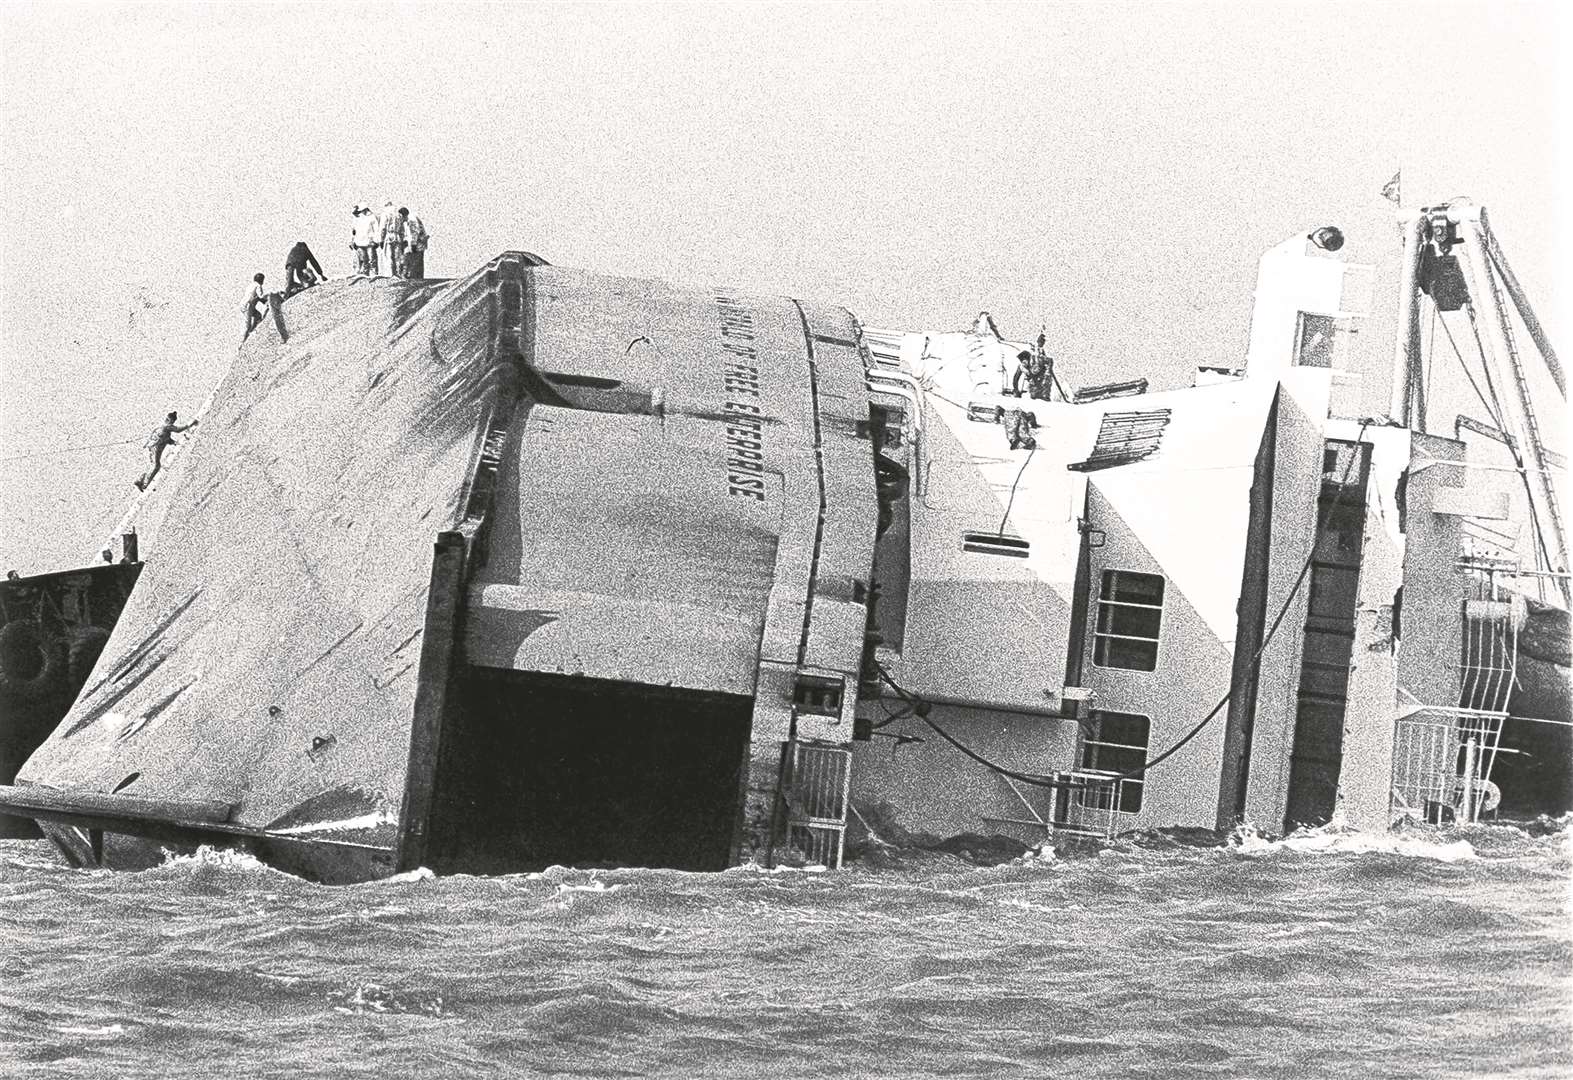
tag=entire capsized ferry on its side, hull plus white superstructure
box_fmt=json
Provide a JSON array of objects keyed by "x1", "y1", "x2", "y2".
[{"x1": 9, "y1": 208, "x2": 1568, "y2": 880}]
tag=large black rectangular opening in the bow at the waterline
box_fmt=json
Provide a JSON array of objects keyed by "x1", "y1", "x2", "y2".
[{"x1": 429, "y1": 668, "x2": 753, "y2": 874}]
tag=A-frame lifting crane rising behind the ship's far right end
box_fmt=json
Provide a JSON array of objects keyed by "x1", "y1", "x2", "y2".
[{"x1": 1391, "y1": 198, "x2": 1573, "y2": 605}]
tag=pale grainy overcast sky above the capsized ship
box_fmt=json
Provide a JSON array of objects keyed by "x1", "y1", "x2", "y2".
[{"x1": 0, "y1": 2, "x2": 1573, "y2": 572}]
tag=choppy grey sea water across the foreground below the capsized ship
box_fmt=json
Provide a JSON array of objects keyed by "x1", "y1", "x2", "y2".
[{"x1": 0, "y1": 821, "x2": 1573, "y2": 1080}]
